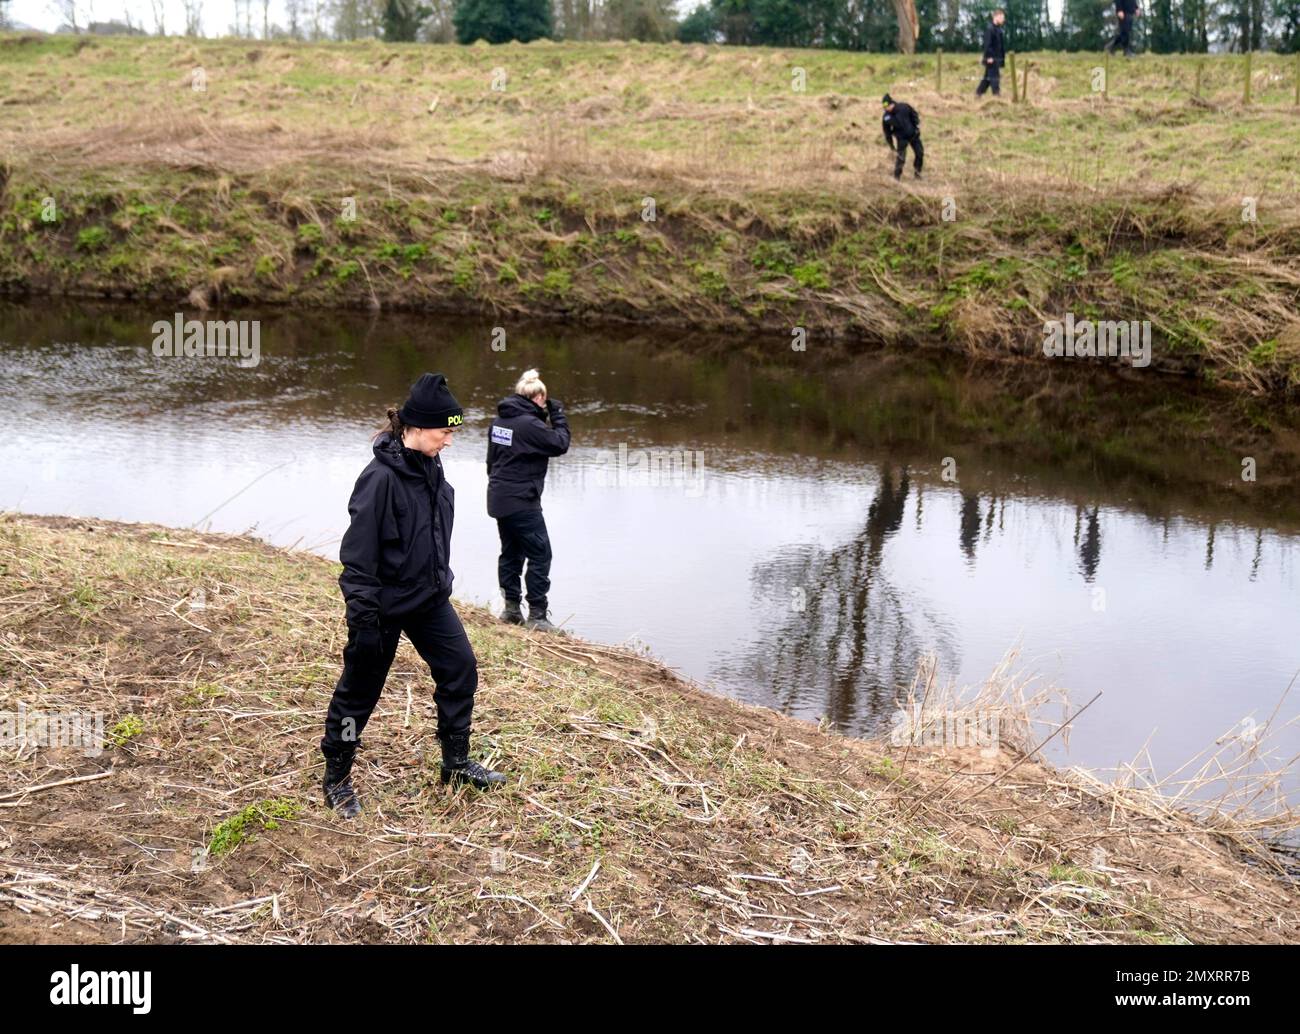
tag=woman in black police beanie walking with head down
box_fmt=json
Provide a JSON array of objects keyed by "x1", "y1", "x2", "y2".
[{"x1": 320, "y1": 373, "x2": 506, "y2": 818}]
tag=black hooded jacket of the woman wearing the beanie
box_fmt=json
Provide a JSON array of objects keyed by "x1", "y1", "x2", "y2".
[{"x1": 338, "y1": 432, "x2": 456, "y2": 628}]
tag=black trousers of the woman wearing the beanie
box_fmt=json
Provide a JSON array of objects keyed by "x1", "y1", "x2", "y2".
[{"x1": 321, "y1": 600, "x2": 478, "y2": 752}]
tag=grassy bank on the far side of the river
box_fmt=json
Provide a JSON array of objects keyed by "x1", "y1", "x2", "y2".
[{"x1": 0, "y1": 36, "x2": 1300, "y2": 395}]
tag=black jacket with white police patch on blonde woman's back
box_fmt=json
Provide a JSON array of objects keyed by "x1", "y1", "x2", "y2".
[{"x1": 488, "y1": 395, "x2": 569, "y2": 518}]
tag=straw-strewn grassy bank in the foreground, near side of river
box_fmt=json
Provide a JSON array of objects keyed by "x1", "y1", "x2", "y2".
[{"x1": 0, "y1": 515, "x2": 1300, "y2": 943}]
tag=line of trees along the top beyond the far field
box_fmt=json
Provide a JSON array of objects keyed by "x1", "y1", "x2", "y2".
[{"x1": 25, "y1": 0, "x2": 1300, "y2": 53}]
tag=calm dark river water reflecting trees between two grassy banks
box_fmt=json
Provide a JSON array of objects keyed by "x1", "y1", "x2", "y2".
[{"x1": 0, "y1": 303, "x2": 1300, "y2": 806}]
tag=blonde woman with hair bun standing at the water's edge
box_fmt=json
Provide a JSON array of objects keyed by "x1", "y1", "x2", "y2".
[{"x1": 488, "y1": 369, "x2": 569, "y2": 632}]
